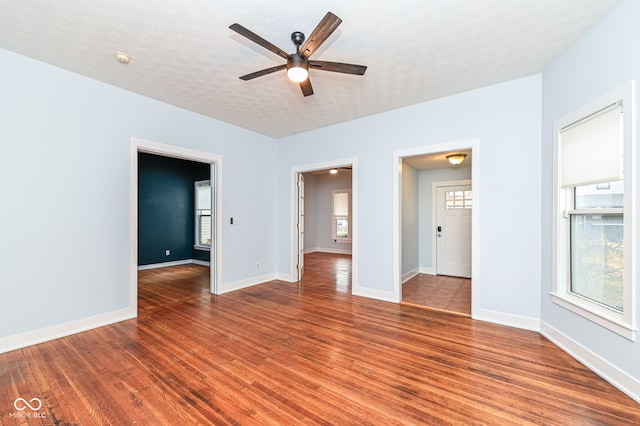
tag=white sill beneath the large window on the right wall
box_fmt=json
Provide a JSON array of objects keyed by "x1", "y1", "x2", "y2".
[{"x1": 551, "y1": 292, "x2": 637, "y2": 342}]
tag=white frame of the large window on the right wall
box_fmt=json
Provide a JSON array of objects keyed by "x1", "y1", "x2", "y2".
[{"x1": 551, "y1": 81, "x2": 637, "y2": 341}]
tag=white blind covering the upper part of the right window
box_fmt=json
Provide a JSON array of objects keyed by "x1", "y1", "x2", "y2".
[{"x1": 560, "y1": 102, "x2": 623, "y2": 188}]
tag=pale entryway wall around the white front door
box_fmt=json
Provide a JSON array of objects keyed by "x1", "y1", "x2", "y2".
[{"x1": 418, "y1": 167, "x2": 471, "y2": 272}]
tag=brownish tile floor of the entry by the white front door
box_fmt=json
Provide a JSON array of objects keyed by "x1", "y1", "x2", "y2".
[{"x1": 402, "y1": 274, "x2": 471, "y2": 317}]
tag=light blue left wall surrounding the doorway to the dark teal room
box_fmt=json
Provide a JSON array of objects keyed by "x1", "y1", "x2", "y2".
[{"x1": 0, "y1": 50, "x2": 277, "y2": 338}]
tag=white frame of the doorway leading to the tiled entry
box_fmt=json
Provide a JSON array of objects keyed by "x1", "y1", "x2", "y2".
[{"x1": 392, "y1": 139, "x2": 482, "y2": 318}]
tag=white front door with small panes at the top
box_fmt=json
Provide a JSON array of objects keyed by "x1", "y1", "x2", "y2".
[{"x1": 435, "y1": 185, "x2": 473, "y2": 278}]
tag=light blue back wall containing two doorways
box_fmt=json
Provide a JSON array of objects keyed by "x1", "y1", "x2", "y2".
[{"x1": 277, "y1": 76, "x2": 541, "y2": 319}]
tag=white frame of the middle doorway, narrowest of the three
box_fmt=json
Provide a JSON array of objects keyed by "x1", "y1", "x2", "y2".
[{"x1": 289, "y1": 157, "x2": 358, "y2": 292}]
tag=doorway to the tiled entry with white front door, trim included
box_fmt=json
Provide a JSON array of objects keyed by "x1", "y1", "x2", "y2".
[{"x1": 394, "y1": 140, "x2": 480, "y2": 317}]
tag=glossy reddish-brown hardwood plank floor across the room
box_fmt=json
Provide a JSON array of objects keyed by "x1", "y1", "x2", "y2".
[{"x1": 0, "y1": 254, "x2": 640, "y2": 425}]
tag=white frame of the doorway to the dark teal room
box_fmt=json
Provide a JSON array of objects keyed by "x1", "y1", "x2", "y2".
[{"x1": 129, "y1": 137, "x2": 222, "y2": 316}]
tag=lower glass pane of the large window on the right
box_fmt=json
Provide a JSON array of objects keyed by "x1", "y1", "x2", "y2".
[{"x1": 571, "y1": 214, "x2": 624, "y2": 312}]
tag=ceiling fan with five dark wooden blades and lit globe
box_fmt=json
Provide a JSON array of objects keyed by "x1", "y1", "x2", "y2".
[{"x1": 229, "y1": 12, "x2": 367, "y2": 96}]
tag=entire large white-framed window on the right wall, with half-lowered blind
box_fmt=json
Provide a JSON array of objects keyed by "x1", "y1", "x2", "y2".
[{"x1": 552, "y1": 84, "x2": 637, "y2": 340}]
